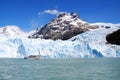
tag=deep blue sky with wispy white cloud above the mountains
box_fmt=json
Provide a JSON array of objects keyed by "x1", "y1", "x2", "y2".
[{"x1": 0, "y1": 0, "x2": 120, "y2": 32}]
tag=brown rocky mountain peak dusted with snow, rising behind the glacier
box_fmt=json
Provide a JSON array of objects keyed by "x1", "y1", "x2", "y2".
[{"x1": 29, "y1": 13, "x2": 97, "y2": 40}]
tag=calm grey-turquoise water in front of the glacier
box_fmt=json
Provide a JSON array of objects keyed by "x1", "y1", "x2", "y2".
[{"x1": 0, "y1": 58, "x2": 120, "y2": 80}]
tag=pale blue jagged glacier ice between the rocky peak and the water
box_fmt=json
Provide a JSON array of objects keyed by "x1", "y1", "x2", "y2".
[{"x1": 0, "y1": 23, "x2": 120, "y2": 58}]
